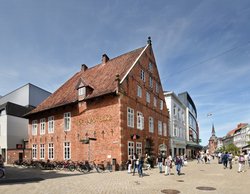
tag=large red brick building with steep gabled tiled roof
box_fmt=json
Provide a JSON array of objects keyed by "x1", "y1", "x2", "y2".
[{"x1": 26, "y1": 39, "x2": 169, "y2": 167}]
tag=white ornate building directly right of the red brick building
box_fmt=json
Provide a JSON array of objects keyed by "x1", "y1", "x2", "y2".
[{"x1": 164, "y1": 91, "x2": 187, "y2": 157}]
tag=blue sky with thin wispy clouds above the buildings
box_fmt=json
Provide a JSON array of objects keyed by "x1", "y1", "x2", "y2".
[{"x1": 0, "y1": 0, "x2": 250, "y2": 145}]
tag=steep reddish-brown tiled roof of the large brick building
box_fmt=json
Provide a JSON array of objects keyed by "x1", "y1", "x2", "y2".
[{"x1": 26, "y1": 44, "x2": 149, "y2": 116}]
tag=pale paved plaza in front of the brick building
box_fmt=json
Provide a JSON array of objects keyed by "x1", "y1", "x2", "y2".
[{"x1": 0, "y1": 160, "x2": 250, "y2": 194}]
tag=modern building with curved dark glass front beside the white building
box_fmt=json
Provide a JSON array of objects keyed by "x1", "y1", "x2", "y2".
[{"x1": 178, "y1": 92, "x2": 202, "y2": 158}]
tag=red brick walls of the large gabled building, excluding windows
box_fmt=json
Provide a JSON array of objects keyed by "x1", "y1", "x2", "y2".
[{"x1": 25, "y1": 41, "x2": 169, "y2": 167}]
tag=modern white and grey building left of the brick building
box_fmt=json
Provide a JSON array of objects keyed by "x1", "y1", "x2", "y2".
[{"x1": 0, "y1": 83, "x2": 51, "y2": 163}]
